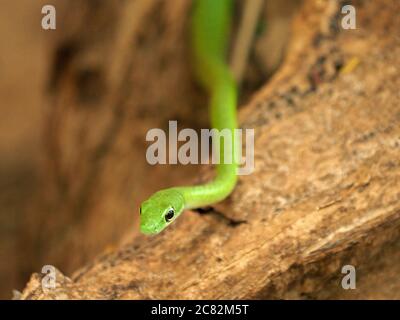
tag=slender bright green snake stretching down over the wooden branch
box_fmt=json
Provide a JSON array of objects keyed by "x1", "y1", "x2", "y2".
[{"x1": 140, "y1": 0, "x2": 238, "y2": 235}]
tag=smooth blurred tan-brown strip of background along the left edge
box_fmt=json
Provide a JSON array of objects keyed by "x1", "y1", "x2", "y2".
[{"x1": 0, "y1": 0, "x2": 50, "y2": 298}]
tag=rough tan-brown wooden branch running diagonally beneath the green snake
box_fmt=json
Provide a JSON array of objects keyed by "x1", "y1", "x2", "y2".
[{"x1": 22, "y1": 0, "x2": 400, "y2": 299}]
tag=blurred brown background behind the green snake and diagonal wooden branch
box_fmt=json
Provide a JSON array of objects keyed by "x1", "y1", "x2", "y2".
[{"x1": 0, "y1": 0, "x2": 301, "y2": 299}]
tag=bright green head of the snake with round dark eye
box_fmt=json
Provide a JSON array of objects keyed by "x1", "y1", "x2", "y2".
[{"x1": 140, "y1": 188, "x2": 184, "y2": 234}]
